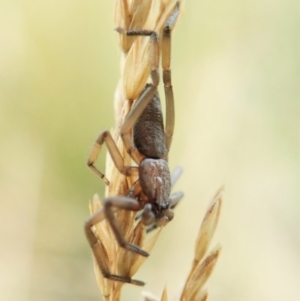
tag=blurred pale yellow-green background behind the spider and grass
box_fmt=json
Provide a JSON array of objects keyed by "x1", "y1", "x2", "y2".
[{"x1": 0, "y1": 0, "x2": 299, "y2": 301}]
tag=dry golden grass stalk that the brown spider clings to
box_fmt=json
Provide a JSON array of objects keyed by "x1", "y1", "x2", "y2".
[{"x1": 90, "y1": 0, "x2": 183, "y2": 301}]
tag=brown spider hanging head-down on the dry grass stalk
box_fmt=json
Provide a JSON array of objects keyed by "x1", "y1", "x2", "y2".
[{"x1": 85, "y1": 2, "x2": 183, "y2": 285}]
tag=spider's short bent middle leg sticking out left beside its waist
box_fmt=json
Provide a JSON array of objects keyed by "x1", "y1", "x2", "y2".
[{"x1": 87, "y1": 131, "x2": 138, "y2": 185}]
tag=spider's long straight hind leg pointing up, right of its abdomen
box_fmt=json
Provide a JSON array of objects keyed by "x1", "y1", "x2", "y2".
[{"x1": 161, "y1": 2, "x2": 179, "y2": 151}]
